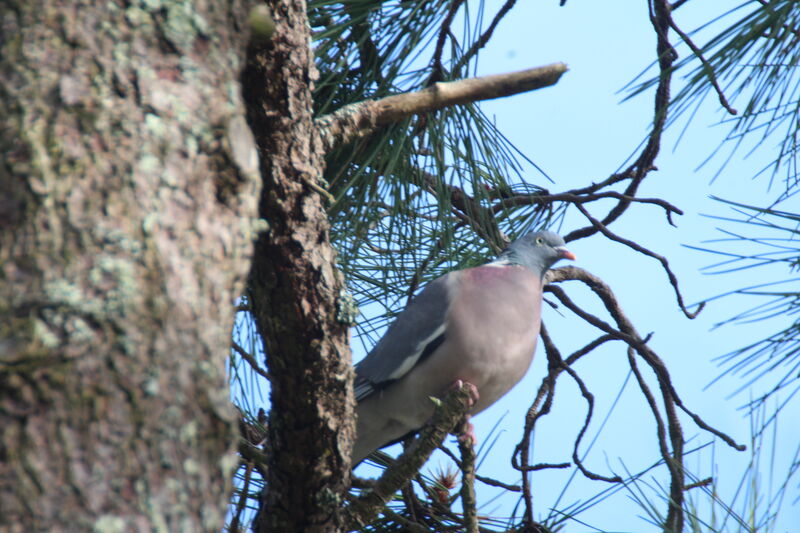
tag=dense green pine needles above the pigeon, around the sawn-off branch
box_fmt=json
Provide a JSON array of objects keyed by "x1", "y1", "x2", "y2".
[{"x1": 309, "y1": 1, "x2": 561, "y2": 345}]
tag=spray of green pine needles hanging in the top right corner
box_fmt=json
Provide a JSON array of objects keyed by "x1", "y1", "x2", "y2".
[{"x1": 633, "y1": 0, "x2": 800, "y2": 197}]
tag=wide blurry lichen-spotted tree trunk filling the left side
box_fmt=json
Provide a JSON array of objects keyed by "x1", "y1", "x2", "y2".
[{"x1": 0, "y1": 0, "x2": 258, "y2": 531}]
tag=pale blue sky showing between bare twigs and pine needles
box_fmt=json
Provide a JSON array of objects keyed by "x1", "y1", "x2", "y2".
[{"x1": 354, "y1": 0, "x2": 800, "y2": 533}]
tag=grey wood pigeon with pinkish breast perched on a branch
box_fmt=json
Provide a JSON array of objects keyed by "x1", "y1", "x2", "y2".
[{"x1": 353, "y1": 231, "x2": 575, "y2": 465}]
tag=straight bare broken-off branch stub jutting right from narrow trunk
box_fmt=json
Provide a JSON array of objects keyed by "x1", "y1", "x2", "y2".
[{"x1": 315, "y1": 63, "x2": 567, "y2": 152}]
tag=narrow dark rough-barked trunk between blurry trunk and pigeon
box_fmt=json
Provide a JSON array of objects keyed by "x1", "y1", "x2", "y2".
[{"x1": 242, "y1": 0, "x2": 354, "y2": 532}]
